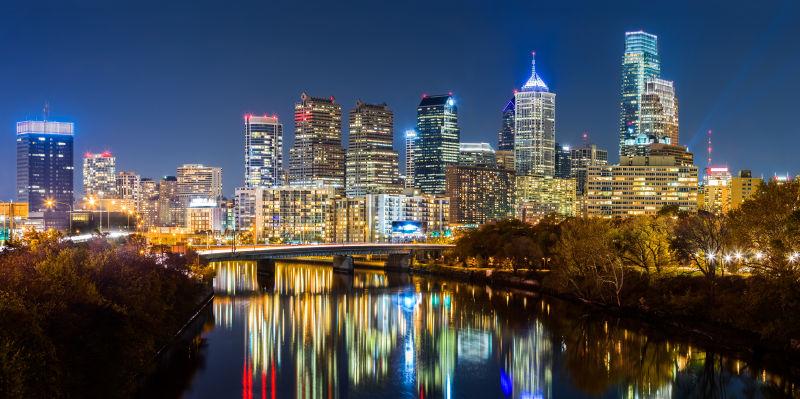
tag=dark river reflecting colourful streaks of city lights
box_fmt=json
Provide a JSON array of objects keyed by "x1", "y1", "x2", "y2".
[{"x1": 166, "y1": 262, "x2": 798, "y2": 399}]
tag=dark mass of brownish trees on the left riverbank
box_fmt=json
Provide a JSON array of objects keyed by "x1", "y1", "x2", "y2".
[{"x1": 0, "y1": 232, "x2": 211, "y2": 398}]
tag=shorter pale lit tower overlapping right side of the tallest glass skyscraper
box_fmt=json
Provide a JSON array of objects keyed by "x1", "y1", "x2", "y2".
[{"x1": 639, "y1": 78, "x2": 678, "y2": 145}]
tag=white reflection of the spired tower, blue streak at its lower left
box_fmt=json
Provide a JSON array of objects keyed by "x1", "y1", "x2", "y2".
[{"x1": 500, "y1": 320, "x2": 553, "y2": 399}]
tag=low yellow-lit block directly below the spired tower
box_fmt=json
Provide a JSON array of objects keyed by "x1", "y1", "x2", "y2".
[{"x1": 515, "y1": 176, "x2": 578, "y2": 224}]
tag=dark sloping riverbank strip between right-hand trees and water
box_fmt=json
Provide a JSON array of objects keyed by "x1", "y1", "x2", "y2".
[{"x1": 411, "y1": 264, "x2": 800, "y2": 379}]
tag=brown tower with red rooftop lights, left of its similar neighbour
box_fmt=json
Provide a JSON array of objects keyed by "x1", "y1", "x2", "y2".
[{"x1": 289, "y1": 93, "x2": 345, "y2": 188}]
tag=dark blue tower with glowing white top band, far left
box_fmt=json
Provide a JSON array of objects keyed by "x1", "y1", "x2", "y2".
[{"x1": 17, "y1": 121, "x2": 74, "y2": 212}]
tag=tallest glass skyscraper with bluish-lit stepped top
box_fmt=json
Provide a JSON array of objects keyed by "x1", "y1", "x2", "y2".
[{"x1": 619, "y1": 31, "x2": 661, "y2": 154}]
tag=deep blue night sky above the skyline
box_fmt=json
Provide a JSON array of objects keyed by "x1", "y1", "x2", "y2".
[{"x1": 0, "y1": 0, "x2": 800, "y2": 201}]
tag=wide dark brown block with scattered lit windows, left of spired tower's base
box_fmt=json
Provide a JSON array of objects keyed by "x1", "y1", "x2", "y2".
[{"x1": 446, "y1": 165, "x2": 514, "y2": 225}]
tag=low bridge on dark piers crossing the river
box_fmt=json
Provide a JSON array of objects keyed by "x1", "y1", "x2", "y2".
[{"x1": 197, "y1": 243, "x2": 453, "y2": 273}]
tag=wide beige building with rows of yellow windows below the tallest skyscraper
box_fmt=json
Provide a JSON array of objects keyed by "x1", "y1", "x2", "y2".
[{"x1": 586, "y1": 156, "x2": 698, "y2": 217}]
